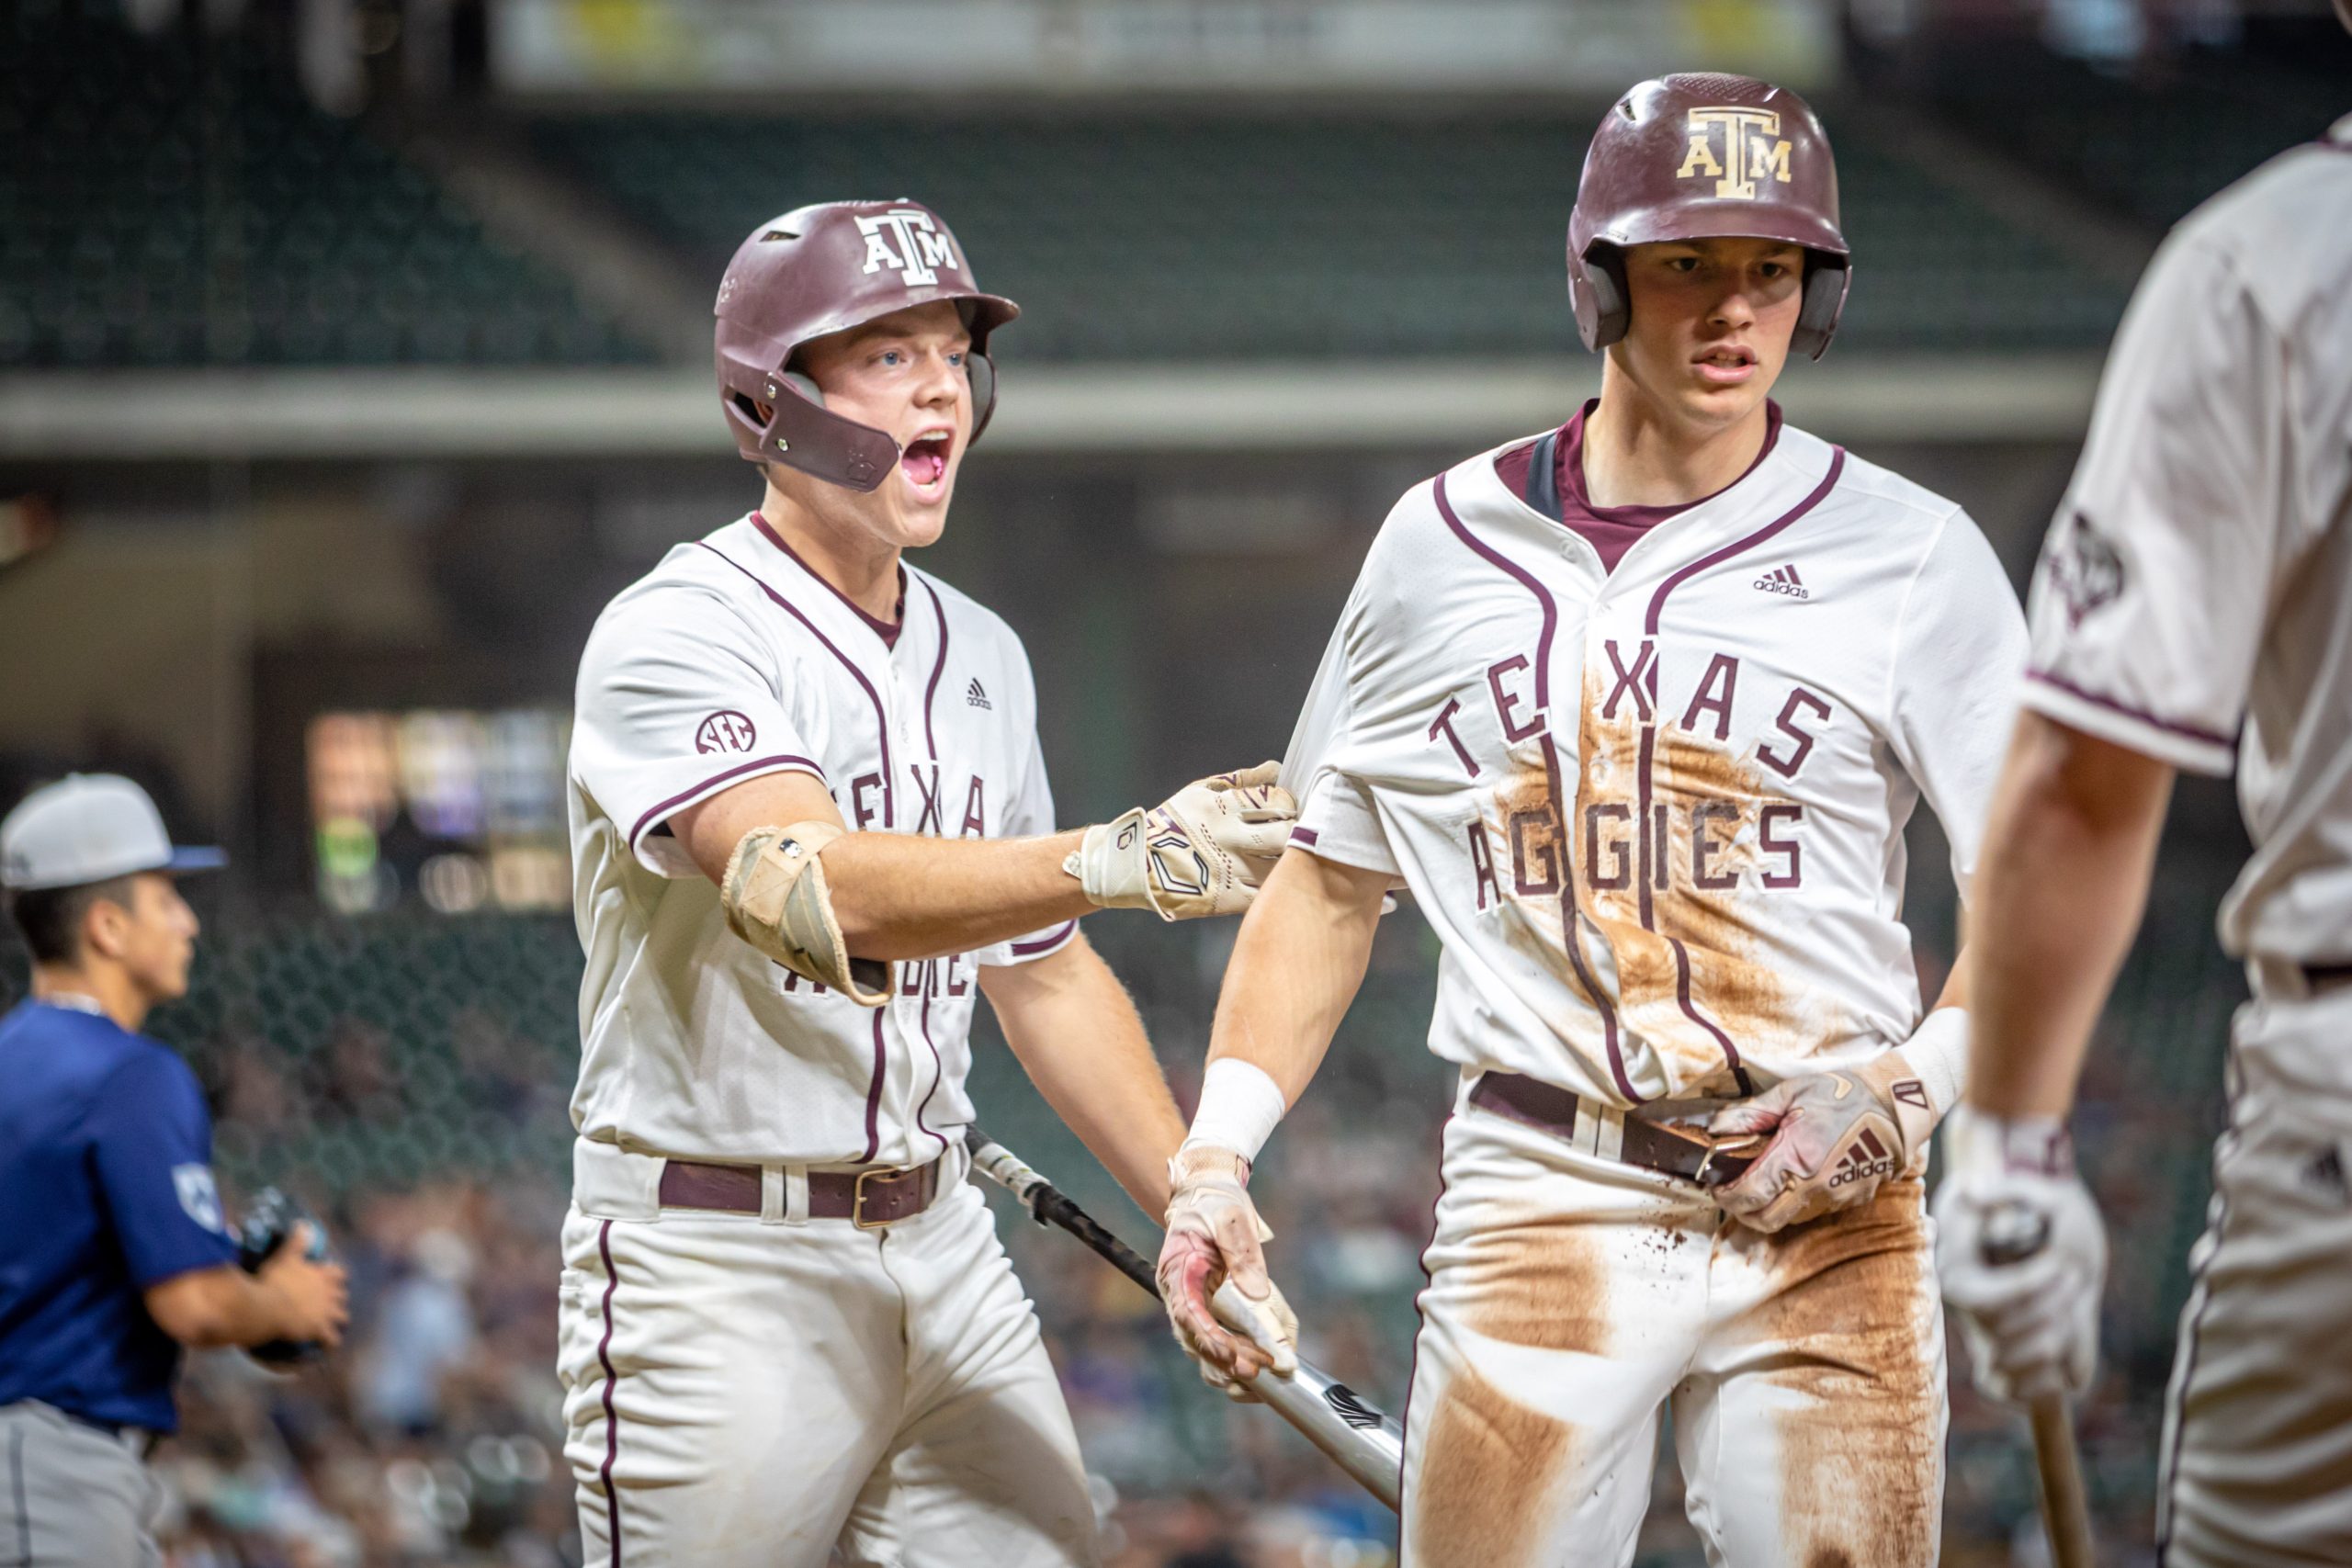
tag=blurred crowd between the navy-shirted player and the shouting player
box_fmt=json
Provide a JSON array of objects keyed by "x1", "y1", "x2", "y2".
[{"x1": 155, "y1": 1176, "x2": 579, "y2": 1568}]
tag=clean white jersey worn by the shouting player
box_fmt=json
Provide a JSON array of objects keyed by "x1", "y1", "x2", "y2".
[{"x1": 570, "y1": 514, "x2": 1077, "y2": 1164}]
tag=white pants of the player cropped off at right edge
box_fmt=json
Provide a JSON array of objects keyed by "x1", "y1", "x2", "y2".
[{"x1": 2157, "y1": 995, "x2": 2352, "y2": 1568}]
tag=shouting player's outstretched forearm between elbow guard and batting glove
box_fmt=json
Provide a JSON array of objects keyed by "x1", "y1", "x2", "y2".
[{"x1": 826, "y1": 832, "x2": 1093, "y2": 959}]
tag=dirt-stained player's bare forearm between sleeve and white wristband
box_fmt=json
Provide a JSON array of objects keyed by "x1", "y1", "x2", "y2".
[{"x1": 1209, "y1": 849, "x2": 1387, "y2": 1102}]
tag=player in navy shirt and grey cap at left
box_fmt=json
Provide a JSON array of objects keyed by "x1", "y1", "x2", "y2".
[{"x1": 0, "y1": 773, "x2": 345, "y2": 1568}]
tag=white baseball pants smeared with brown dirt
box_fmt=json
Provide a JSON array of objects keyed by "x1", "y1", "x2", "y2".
[{"x1": 1402, "y1": 1090, "x2": 1945, "y2": 1568}]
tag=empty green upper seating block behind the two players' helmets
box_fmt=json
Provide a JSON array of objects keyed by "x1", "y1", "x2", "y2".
[{"x1": 534, "y1": 108, "x2": 2154, "y2": 360}]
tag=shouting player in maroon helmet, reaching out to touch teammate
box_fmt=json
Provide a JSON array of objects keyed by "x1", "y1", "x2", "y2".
[{"x1": 562, "y1": 200, "x2": 1294, "y2": 1568}]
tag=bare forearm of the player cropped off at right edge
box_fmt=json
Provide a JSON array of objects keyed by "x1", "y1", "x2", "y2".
[{"x1": 1964, "y1": 712, "x2": 2173, "y2": 1117}]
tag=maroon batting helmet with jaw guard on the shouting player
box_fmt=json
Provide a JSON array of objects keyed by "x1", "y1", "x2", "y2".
[{"x1": 715, "y1": 200, "x2": 1021, "y2": 489}]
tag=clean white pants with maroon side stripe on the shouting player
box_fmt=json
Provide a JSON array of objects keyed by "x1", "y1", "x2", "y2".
[{"x1": 560, "y1": 1142, "x2": 1096, "y2": 1568}]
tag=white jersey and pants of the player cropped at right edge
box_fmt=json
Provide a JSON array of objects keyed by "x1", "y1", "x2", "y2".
[{"x1": 2025, "y1": 118, "x2": 2352, "y2": 1568}]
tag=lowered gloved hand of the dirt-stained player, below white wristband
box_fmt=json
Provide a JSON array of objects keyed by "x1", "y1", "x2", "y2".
[{"x1": 1158, "y1": 1143, "x2": 1298, "y2": 1399}]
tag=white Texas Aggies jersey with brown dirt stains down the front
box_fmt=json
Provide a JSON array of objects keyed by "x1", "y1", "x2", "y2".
[{"x1": 1286, "y1": 415, "x2": 2025, "y2": 1105}]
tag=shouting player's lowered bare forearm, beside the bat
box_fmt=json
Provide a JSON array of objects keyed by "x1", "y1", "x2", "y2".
[{"x1": 981, "y1": 938, "x2": 1183, "y2": 1220}]
